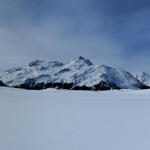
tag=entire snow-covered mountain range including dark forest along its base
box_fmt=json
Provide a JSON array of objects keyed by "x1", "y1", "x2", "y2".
[{"x1": 0, "y1": 57, "x2": 150, "y2": 90}]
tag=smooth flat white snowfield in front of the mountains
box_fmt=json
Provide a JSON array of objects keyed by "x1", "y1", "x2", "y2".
[{"x1": 0, "y1": 87, "x2": 150, "y2": 150}]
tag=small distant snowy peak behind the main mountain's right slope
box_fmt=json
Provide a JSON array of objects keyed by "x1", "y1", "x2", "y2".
[{"x1": 133, "y1": 72, "x2": 150, "y2": 86}]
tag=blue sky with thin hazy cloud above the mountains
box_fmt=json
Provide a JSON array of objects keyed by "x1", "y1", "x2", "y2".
[{"x1": 0, "y1": 0, "x2": 150, "y2": 73}]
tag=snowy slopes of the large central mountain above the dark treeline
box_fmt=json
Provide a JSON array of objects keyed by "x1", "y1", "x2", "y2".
[{"x1": 0, "y1": 57, "x2": 149, "y2": 89}]
